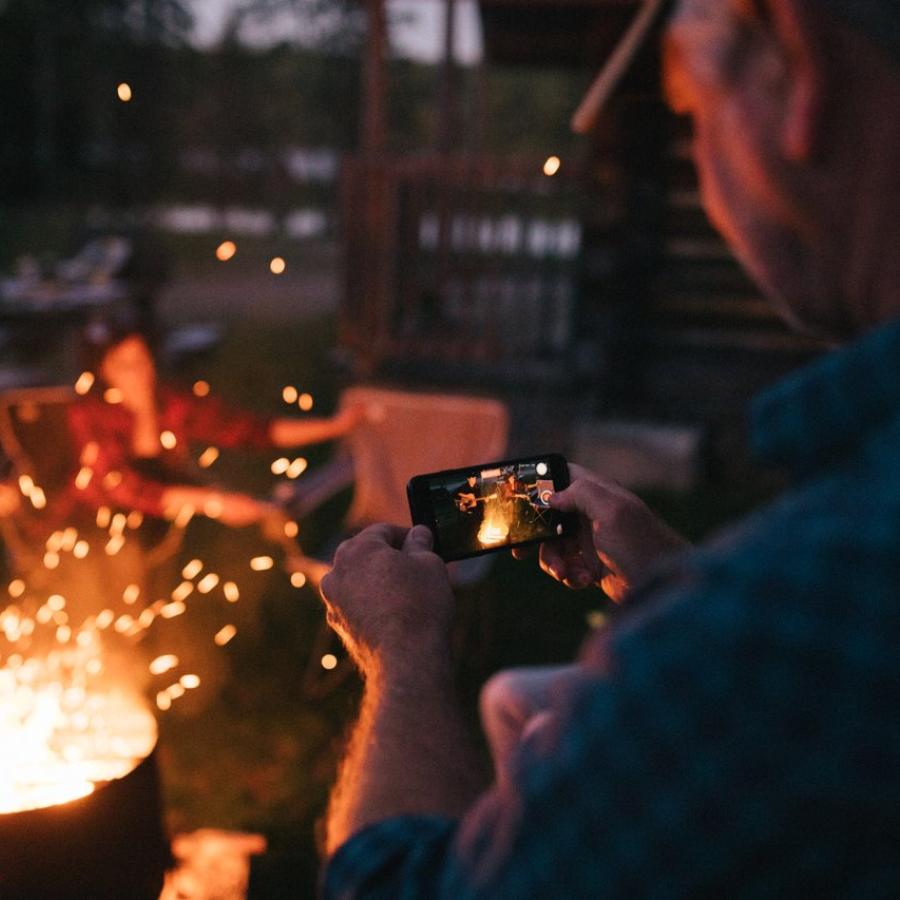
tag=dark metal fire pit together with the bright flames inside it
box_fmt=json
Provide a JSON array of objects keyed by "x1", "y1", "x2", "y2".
[{"x1": 0, "y1": 607, "x2": 170, "y2": 900}]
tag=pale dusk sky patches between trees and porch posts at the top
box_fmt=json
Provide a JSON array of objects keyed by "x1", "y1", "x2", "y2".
[{"x1": 191, "y1": 0, "x2": 481, "y2": 63}]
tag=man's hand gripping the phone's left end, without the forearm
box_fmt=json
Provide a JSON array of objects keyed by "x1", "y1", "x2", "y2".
[{"x1": 321, "y1": 525, "x2": 453, "y2": 674}]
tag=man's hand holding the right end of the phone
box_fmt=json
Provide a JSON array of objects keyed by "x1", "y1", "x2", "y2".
[{"x1": 516, "y1": 463, "x2": 688, "y2": 602}]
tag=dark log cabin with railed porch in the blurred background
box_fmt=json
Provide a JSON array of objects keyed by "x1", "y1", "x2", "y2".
[{"x1": 341, "y1": 0, "x2": 820, "y2": 486}]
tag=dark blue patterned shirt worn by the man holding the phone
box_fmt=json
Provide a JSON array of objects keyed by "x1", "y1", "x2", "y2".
[{"x1": 322, "y1": 322, "x2": 900, "y2": 900}]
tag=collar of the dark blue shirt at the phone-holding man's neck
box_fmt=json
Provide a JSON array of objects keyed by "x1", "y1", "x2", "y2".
[{"x1": 751, "y1": 319, "x2": 900, "y2": 475}]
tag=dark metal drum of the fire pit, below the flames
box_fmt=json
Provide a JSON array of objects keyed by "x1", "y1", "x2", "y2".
[{"x1": 0, "y1": 749, "x2": 172, "y2": 900}]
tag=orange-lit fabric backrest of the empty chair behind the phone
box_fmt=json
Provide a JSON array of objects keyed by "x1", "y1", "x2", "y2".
[{"x1": 340, "y1": 387, "x2": 509, "y2": 529}]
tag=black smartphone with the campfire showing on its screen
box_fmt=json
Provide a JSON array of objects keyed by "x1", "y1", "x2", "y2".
[{"x1": 406, "y1": 453, "x2": 576, "y2": 562}]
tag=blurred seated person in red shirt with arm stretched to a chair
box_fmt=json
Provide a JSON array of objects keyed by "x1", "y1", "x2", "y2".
[{"x1": 68, "y1": 329, "x2": 362, "y2": 527}]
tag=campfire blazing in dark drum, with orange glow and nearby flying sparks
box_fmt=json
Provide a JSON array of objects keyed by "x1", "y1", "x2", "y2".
[{"x1": 0, "y1": 376, "x2": 311, "y2": 900}]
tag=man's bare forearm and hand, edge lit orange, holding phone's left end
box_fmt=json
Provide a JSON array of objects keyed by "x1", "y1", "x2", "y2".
[{"x1": 322, "y1": 525, "x2": 484, "y2": 853}]
